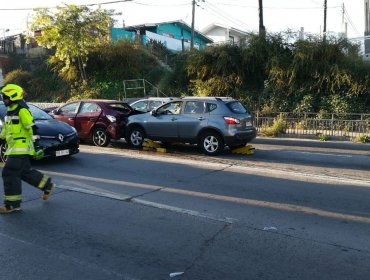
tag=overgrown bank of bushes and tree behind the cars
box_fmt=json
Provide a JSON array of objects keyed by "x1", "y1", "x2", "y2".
[{"x1": 4, "y1": 5, "x2": 370, "y2": 113}]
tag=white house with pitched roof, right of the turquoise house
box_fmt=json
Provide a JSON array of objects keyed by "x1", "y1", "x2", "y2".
[{"x1": 202, "y1": 23, "x2": 249, "y2": 44}]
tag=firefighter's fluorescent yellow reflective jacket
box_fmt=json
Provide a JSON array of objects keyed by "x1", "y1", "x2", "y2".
[{"x1": 0, "y1": 104, "x2": 35, "y2": 155}]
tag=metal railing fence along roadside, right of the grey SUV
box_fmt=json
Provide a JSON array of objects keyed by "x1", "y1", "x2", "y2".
[{"x1": 255, "y1": 112, "x2": 370, "y2": 139}]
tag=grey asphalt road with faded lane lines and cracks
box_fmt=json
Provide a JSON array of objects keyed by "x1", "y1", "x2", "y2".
[{"x1": 0, "y1": 139, "x2": 370, "y2": 280}]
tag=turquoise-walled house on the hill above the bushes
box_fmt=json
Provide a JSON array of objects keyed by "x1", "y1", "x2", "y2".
[{"x1": 112, "y1": 20, "x2": 213, "y2": 52}]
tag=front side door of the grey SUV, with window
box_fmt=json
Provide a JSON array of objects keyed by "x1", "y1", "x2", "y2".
[{"x1": 146, "y1": 101, "x2": 182, "y2": 140}]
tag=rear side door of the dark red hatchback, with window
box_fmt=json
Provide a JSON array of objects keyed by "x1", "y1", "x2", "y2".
[{"x1": 75, "y1": 102, "x2": 102, "y2": 138}]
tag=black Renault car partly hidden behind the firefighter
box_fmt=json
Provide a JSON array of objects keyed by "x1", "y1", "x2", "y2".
[{"x1": 0, "y1": 101, "x2": 79, "y2": 161}]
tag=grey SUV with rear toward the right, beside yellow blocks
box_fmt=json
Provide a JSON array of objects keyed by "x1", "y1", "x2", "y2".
[{"x1": 126, "y1": 97, "x2": 256, "y2": 155}]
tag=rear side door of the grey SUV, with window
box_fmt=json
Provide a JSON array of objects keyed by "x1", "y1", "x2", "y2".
[{"x1": 178, "y1": 100, "x2": 208, "y2": 140}]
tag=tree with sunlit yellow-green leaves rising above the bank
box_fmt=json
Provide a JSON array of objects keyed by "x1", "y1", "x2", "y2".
[{"x1": 29, "y1": 4, "x2": 113, "y2": 82}]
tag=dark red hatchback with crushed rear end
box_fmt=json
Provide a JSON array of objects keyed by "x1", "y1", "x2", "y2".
[{"x1": 49, "y1": 100, "x2": 142, "y2": 147}]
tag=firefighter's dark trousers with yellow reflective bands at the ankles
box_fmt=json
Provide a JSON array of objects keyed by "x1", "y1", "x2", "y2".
[{"x1": 2, "y1": 155, "x2": 50, "y2": 206}]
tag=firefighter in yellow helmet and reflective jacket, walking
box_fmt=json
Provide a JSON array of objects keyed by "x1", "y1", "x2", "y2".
[{"x1": 0, "y1": 84, "x2": 55, "y2": 214}]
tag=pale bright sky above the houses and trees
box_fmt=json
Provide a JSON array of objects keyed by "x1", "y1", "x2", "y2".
[{"x1": 0, "y1": 0, "x2": 365, "y2": 38}]
